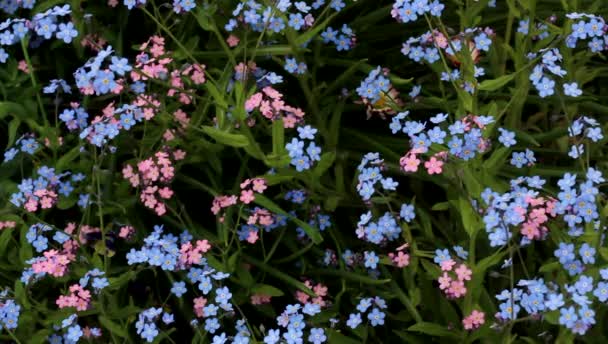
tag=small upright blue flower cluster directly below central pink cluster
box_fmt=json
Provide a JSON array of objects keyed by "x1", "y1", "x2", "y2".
[{"x1": 285, "y1": 125, "x2": 321, "y2": 172}]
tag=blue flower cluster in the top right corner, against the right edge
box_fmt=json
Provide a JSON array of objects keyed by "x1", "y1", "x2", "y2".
[{"x1": 566, "y1": 13, "x2": 606, "y2": 53}]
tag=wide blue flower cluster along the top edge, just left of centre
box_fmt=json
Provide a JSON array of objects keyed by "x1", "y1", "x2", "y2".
[{"x1": 224, "y1": 0, "x2": 346, "y2": 33}]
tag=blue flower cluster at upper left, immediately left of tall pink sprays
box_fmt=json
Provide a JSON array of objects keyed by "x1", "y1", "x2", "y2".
[{"x1": 74, "y1": 45, "x2": 132, "y2": 95}]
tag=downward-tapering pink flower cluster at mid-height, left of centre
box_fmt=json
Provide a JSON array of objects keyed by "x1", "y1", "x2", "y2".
[{"x1": 122, "y1": 151, "x2": 185, "y2": 216}]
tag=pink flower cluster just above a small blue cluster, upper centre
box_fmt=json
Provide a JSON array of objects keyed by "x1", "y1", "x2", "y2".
[{"x1": 245, "y1": 86, "x2": 304, "y2": 128}]
